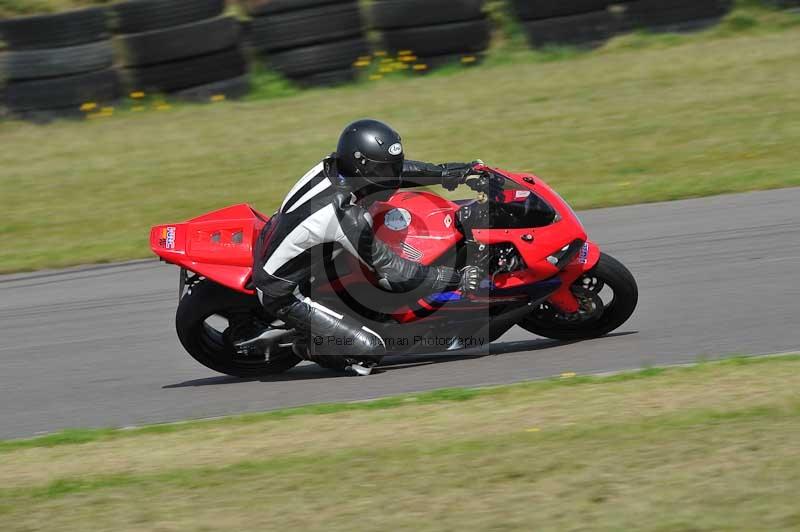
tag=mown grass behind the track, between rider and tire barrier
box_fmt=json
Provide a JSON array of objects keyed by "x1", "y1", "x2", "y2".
[{"x1": 0, "y1": 8, "x2": 800, "y2": 272}]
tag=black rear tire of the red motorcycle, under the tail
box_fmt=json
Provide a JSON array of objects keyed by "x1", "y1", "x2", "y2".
[{"x1": 175, "y1": 281, "x2": 300, "y2": 378}]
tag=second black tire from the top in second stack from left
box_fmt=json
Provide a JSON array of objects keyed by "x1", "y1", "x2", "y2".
[{"x1": 116, "y1": 17, "x2": 239, "y2": 66}]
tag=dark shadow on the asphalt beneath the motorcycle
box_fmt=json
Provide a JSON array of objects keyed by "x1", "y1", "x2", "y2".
[{"x1": 162, "y1": 333, "x2": 620, "y2": 389}]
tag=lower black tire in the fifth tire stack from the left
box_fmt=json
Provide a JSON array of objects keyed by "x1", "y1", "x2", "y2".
[{"x1": 523, "y1": 11, "x2": 621, "y2": 47}]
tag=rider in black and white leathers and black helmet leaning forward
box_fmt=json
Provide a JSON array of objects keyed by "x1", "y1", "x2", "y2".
[{"x1": 253, "y1": 120, "x2": 479, "y2": 375}]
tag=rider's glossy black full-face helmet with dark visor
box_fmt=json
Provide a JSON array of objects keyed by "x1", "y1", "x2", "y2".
[{"x1": 336, "y1": 120, "x2": 405, "y2": 189}]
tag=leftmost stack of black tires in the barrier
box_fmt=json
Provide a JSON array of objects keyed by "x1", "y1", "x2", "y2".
[{"x1": 0, "y1": 8, "x2": 120, "y2": 117}]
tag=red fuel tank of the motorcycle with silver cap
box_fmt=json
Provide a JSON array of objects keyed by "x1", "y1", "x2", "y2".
[{"x1": 370, "y1": 192, "x2": 464, "y2": 265}]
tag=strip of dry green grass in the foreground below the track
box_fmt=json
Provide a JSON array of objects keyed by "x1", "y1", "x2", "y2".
[{"x1": 0, "y1": 356, "x2": 800, "y2": 531}]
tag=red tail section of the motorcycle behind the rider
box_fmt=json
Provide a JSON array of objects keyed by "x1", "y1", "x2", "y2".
[{"x1": 150, "y1": 204, "x2": 269, "y2": 294}]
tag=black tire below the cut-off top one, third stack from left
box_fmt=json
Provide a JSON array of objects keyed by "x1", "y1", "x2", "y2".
[{"x1": 249, "y1": 1, "x2": 364, "y2": 52}]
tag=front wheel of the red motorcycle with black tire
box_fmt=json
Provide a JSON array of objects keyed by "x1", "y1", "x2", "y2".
[{"x1": 519, "y1": 253, "x2": 639, "y2": 340}]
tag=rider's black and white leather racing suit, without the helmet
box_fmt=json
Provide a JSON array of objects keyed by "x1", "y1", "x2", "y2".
[{"x1": 253, "y1": 156, "x2": 461, "y2": 369}]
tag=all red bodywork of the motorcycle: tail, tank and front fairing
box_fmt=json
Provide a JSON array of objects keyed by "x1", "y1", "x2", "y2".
[{"x1": 150, "y1": 166, "x2": 600, "y2": 323}]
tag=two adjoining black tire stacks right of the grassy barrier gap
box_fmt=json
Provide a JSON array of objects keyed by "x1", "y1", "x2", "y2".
[{"x1": 513, "y1": 0, "x2": 731, "y2": 47}]
